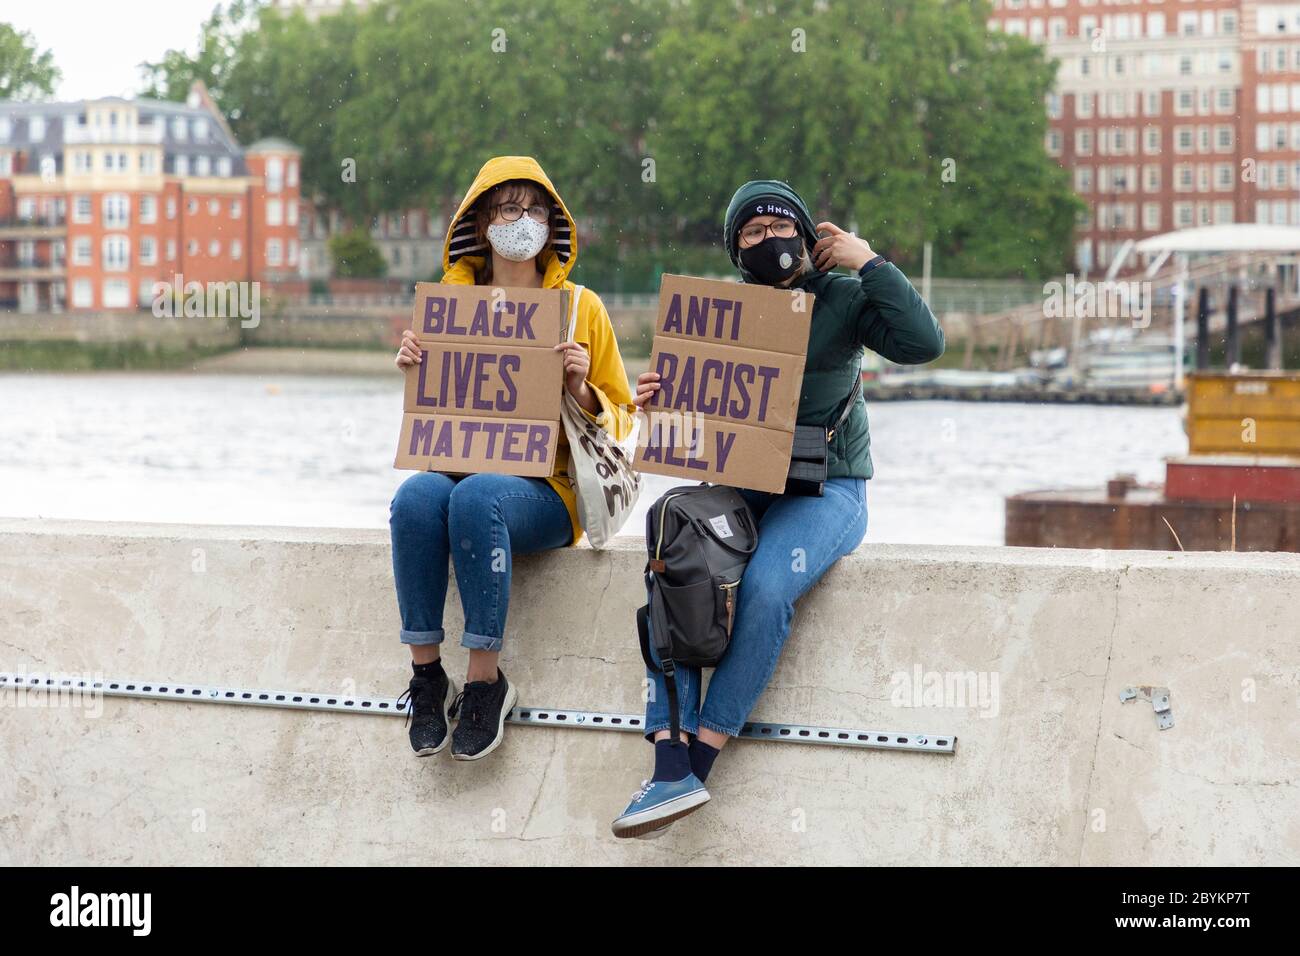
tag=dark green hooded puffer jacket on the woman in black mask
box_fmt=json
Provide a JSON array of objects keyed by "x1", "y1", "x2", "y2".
[{"x1": 724, "y1": 179, "x2": 944, "y2": 479}]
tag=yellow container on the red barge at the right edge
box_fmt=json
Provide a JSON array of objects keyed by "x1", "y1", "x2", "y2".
[{"x1": 1187, "y1": 372, "x2": 1300, "y2": 458}]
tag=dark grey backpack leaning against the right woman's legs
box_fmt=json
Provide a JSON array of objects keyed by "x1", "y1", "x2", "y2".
[{"x1": 637, "y1": 484, "x2": 758, "y2": 740}]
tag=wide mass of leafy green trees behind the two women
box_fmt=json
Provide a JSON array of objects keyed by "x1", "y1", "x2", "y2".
[{"x1": 142, "y1": 0, "x2": 1080, "y2": 277}]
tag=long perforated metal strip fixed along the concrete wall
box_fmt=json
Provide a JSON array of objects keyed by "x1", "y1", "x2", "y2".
[{"x1": 0, "y1": 674, "x2": 957, "y2": 753}]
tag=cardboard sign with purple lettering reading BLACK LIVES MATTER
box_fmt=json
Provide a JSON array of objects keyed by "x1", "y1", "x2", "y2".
[{"x1": 394, "y1": 282, "x2": 569, "y2": 477}]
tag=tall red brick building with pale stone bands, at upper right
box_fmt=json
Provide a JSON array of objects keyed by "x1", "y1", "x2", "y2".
[{"x1": 989, "y1": 0, "x2": 1300, "y2": 272}]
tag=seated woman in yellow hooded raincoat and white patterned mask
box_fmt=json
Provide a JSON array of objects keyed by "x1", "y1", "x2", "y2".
[{"x1": 389, "y1": 156, "x2": 632, "y2": 760}]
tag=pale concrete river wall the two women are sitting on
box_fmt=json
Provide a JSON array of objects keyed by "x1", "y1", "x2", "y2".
[{"x1": 0, "y1": 520, "x2": 1300, "y2": 866}]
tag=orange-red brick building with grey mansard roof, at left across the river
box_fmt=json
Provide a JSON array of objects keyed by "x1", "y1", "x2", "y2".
[{"x1": 0, "y1": 83, "x2": 300, "y2": 311}]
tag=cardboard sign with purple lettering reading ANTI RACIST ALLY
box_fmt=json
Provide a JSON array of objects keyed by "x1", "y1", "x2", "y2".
[{"x1": 636, "y1": 276, "x2": 814, "y2": 492}]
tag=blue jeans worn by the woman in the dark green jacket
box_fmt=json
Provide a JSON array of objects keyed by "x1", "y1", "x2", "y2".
[{"x1": 646, "y1": 477, "x2": 867, "y2": 739}]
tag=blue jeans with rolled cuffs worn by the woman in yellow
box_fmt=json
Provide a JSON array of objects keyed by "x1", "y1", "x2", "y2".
[{"x1": 389, "y1": 471, "x2": 573, "y2": 650}]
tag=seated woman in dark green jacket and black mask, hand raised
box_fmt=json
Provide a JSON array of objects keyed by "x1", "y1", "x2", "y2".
[{"x1": 614, "y1": 179, "x2": 944, "y2": 838}]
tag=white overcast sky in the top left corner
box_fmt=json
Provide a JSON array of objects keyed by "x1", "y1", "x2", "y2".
[{"x1": 0, "y1": 0, "x2": 217, "y2": 100}]
